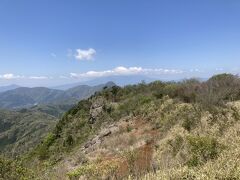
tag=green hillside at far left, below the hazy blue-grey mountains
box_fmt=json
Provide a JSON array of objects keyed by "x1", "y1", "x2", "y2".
[{"x1": 0, "y1": 109, "x2": 58, "y2": 157}]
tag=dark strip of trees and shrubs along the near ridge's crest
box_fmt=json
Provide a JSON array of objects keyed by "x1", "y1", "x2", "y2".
[{"x1": 98, "y1": 74, "x2": 240, "y2": 108}]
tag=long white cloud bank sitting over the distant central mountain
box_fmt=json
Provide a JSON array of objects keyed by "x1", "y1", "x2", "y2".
[{"x1": 70, "y1": 66, "x2": 183, "y2": 78}]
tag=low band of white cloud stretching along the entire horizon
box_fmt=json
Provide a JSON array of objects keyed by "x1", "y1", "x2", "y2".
[{"x1": 3, "y1": 66, "x2": 232, "y2": 81}]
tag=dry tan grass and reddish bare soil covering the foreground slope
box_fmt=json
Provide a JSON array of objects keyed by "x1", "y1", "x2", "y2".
[{"x1": 64, "y1": 99, "x2": 240, "y2": 180}]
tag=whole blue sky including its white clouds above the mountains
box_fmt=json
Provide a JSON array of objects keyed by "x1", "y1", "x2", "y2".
[{"x1": 0, "y1": 0, "x2": 240, "y2": 86}]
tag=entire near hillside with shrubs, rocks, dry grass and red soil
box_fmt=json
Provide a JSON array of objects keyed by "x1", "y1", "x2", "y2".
[{"x1": 3, "y1": 74, "x2": 240, "y2": 180}]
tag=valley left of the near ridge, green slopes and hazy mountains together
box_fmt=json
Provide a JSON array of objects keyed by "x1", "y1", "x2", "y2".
[{"x1": 0, "y1": 82, "x2": 113, "y2": 157}]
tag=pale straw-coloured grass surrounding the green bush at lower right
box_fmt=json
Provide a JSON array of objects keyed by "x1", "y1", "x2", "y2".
[{"x1": 132, "y1": 102, "x2": 240, "y2": 180}]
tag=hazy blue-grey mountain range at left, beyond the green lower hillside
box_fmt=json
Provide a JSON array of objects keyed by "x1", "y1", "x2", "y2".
[{"x1": 0, "y1": 82, "x2": 115, "y2": 109}]
